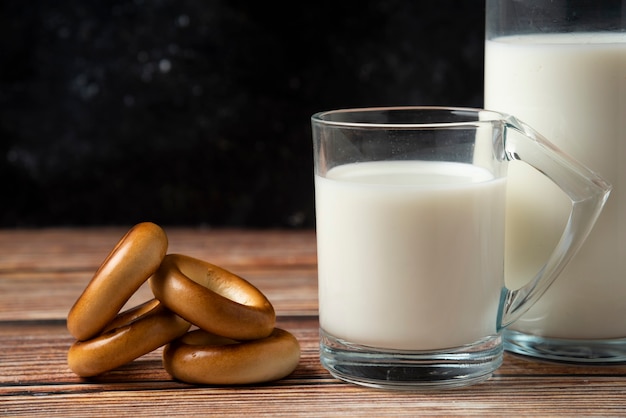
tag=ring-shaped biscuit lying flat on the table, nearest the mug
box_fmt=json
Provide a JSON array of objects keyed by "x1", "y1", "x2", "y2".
[{"x1": 163, "y1": 328, "x2": 300, "y2": 385}]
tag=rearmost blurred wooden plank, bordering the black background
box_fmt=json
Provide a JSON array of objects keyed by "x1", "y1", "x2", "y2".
[{"x1": 0, "y1": 227, "x2": 317, "y2": 273}]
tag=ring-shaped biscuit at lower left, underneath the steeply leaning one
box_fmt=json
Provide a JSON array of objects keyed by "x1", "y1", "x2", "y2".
[{"x1": 67, "y1": 299, "x2": 191, "y2": 377}]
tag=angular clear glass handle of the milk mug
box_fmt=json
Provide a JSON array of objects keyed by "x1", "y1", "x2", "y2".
[{"x1": 496, "y1": 115, "x2": 612, "y2": 328}]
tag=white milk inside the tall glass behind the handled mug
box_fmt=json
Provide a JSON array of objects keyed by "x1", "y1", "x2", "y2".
[{"x1": 485, "y1": 33, "x2": 626, "y2": 339}]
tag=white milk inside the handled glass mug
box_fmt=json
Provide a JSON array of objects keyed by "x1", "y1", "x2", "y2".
[{"x1": 315, "y1": 161, "x2": 505, "y2": 350}]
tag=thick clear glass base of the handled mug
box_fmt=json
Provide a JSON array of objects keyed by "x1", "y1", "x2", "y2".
[{"x1": 320, "y1": 329, "x2": 504, "y2": 390}]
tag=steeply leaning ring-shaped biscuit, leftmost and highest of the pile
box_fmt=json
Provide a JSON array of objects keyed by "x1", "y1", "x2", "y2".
[{"x1": 67, "y1": 222, "x2": 167, "y2": 340}]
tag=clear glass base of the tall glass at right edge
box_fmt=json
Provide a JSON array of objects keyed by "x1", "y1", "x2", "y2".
[{"x1": 504, "y1": 330, "x2": 626, "y2": 364}]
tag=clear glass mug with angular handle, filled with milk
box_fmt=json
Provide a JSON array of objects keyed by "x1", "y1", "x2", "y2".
[{"x1": 312, "y1": 107, "x2": 610, "y2": 389}]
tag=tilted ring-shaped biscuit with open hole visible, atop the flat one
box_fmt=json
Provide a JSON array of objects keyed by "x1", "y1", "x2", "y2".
[{"x1": 150, "y1": 254, "x2": 276, "y2": 340}]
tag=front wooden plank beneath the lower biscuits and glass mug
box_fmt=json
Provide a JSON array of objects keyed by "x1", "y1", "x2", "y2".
[{"x1": 0, "y1": 317, "x2": 626, "y2": 417}]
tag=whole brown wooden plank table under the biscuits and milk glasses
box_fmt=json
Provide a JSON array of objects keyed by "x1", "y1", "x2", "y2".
[{"x1": 0, "y1": 227, "x2": 626, "y2": 417}]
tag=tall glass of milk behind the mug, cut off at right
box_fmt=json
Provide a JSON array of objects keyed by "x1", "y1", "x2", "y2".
[{"x1": 485, "y1": 0, "x2": 626, "y2": 363}]
